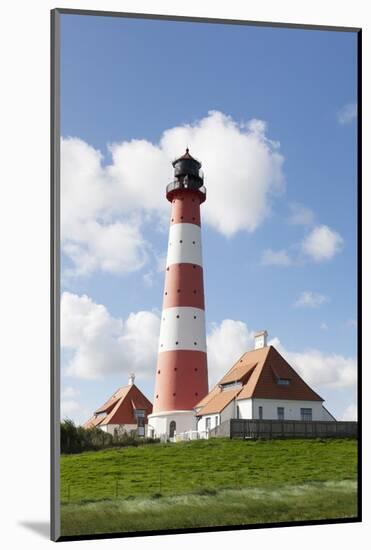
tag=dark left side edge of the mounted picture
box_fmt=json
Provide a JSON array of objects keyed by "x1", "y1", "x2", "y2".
[{"x1": 50, "y1": 9, "x2": 61, "y2": 541}]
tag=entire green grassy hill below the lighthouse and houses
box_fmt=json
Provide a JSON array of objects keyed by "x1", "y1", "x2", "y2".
[{"x1": 61, "y1": 439, "x2": 357, "y2": 535}]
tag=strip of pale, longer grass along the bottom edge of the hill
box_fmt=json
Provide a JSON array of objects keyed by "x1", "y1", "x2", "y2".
[{"x1": 61, "y1": 481, "x2": 357, "y2": 535}]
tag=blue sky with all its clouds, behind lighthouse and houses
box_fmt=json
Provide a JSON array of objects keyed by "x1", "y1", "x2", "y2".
[{"x1": 61, "y1": 15, "x2": 357, "y2": 422}]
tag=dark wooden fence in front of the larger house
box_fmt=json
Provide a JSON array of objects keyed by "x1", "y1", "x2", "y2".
[{"x1": 221, "y1": 419, "x2": 358, "y2": 439}]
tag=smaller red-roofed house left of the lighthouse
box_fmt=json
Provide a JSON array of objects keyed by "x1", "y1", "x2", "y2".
[{"x1": 83, "y1": 374, "x2": 152, "y2": 436}]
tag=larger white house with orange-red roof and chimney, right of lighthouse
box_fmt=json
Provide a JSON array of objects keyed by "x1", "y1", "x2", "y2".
[{"x1": 195, "y1": 331, "x2": 336, "y2": 433}]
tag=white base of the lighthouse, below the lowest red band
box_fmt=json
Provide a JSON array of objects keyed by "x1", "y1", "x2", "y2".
[{"x1": 147, "y1": 410, "x2": 196, "y2": 440}]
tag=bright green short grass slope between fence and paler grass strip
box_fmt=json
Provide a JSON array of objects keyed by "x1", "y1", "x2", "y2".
[{"x1": 61, "y1": 439, "x2": 357, "y2": 504}]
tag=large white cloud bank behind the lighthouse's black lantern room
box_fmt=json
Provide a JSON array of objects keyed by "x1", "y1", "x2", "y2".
[{"x1": 61, "y1": 111, "x2": 284, "y2": 275}]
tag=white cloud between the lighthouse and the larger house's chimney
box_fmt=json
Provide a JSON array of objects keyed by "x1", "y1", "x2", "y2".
[{"x1": 207, "y1": 319, "x2": 254, "y2": 387}]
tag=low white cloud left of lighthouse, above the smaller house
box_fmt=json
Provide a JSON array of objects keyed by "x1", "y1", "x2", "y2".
[{"x1": 61, "y1": 292, "x2": 160, "y2": 379}]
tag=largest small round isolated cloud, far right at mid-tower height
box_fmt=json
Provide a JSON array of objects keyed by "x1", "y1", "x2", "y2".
[{"x1": 302, "y1": 225, "x2": 344, "y2": 262}]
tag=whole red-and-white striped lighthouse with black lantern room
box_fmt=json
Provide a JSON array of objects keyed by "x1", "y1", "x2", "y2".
[{"x1": 148, "y1": 148, "x2": 208, "y2": 437}]
